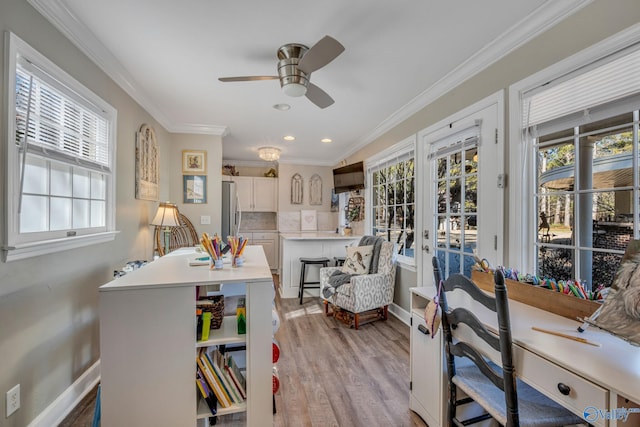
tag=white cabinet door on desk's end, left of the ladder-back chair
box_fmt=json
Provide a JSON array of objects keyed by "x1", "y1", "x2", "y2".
[{"x1": 410, "y1": 314, "x2": 443, "y2": 426}]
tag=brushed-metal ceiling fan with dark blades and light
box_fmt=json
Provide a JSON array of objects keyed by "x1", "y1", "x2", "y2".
[{"x1": 218, "y1": 36, "x2": 344, "y2": 108}]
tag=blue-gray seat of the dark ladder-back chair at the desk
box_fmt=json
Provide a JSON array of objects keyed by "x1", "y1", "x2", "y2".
[{"x1": 452, "y1": 358, "x2": 583, "y2": 427}]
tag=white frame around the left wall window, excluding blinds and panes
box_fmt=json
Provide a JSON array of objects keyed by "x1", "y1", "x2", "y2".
[{"x1": 2, "y1": 32, "x2": 117, "y2": 262}]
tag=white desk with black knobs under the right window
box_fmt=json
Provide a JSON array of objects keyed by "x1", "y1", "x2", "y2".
[{"x1": 411, "y1": 287, "x2": 640, "y2": 427}]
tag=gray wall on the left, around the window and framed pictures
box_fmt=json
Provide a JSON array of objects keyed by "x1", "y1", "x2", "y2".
[{"x1": 0, "y1": 0, "x2": 222, "y2": 427}]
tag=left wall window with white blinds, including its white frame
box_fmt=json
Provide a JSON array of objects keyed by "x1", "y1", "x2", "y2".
[{"x1": 4, "y1": 34, "x2": 116, "y2": 261}]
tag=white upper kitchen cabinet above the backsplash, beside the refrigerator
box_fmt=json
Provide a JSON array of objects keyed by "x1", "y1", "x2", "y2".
[{"x1": 231, "y1": 176, "x2": 278, "y2": 212}]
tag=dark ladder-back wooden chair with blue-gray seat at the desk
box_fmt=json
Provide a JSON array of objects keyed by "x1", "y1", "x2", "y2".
[{"x1": 432, "y1": 257, "x2": 584, "y2": 427}]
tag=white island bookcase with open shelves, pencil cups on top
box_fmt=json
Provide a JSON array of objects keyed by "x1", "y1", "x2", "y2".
[{"x1": 99, "y1": 246, "x2": 274, "y2": 427}]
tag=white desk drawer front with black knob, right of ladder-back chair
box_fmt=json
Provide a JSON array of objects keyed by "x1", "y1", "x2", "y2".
[{"x1": 514, "y1": 345, "x2": 609, "y2": 426}]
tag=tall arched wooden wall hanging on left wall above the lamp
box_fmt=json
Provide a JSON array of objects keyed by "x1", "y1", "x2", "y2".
[{"x1": 136, "y1": 124, "x2": 160, "y2": 202}]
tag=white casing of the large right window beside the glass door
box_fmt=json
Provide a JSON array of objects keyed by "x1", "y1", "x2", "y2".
[{"x1": 505, "y1": 24, "x2": 640, "y2": 271}]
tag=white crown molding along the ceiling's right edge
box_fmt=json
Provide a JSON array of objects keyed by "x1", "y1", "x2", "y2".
[{"x1": 337, "y1": 0, "x2": 593, "y2": 161}]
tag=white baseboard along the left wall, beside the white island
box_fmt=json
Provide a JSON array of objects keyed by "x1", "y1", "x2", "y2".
[{"x1": 29, "y1": 360, "x2": 100, "y2": 427}]
